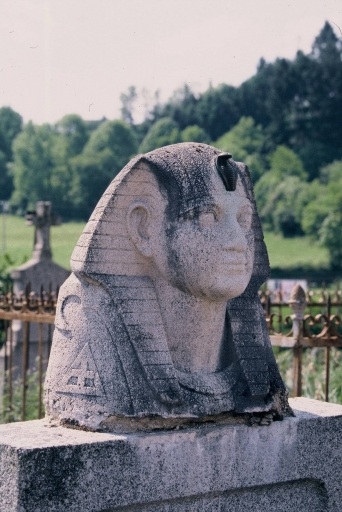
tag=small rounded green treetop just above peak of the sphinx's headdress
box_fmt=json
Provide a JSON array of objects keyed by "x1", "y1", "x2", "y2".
[{"x1": 139, "y1": 117, "x2": 182, "y2": 153}]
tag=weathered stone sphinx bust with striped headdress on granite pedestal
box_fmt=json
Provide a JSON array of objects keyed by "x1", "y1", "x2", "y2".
[{"x1": 45, "y1": 143, "x2": 291, "y2": 430}]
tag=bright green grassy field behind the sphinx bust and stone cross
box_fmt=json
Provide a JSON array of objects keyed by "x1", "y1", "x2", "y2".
[{"x1": 0, "y1": 215, "x2": 328, "y2": 270}]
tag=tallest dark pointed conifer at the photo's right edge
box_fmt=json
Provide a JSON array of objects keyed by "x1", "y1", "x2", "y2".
[{"x1": 290, "y1": 22, "x2": 342, "y2": 174}]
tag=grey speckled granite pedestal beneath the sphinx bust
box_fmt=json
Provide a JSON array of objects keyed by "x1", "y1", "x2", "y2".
[{"x1": 0, "y1": 398, "x2": 342, "y2": 512}]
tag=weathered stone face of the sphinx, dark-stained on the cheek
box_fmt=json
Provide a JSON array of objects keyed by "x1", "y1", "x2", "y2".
[{"x1": 153, "y1": 168, "x2": 254, "y2": 301}]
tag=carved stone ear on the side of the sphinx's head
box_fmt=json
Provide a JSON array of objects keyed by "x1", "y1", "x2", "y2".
[{"x1": 127, "y1": 201, "x2": 152, "y2": 257}]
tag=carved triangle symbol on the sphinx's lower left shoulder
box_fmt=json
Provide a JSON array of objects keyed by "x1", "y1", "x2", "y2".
[{"x1": 58, "y1": 343, "x2": 105, "y2": 396}]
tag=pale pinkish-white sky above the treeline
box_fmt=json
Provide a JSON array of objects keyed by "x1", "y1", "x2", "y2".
[{"x1": 0, "y1": 0, "x2": 342, "y2": 124}]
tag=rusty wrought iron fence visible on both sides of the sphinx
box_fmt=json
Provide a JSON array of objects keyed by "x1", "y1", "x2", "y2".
[{"x1": 0, "y1": 286, "x2": 342, "y2": 422}]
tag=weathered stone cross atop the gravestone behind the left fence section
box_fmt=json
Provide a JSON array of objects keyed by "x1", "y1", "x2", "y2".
[{"x1": 26, "y1": 201, "x2": 61, "y2": 261}]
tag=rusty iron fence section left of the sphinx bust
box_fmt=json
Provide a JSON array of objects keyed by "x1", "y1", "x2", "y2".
[{"x1": 0, "y1": 286, "x2": 58, "y2": 422}]
